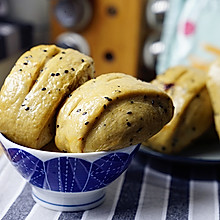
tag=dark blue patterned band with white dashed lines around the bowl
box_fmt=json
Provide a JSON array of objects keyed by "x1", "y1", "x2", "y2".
[{"x1": 5, "y1": 145, "x2": 140, "y2": 192}]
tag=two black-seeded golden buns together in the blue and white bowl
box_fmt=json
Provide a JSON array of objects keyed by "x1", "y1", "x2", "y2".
[{"x1": 0, "y1": 45, "x2": 173, "y2": 152}]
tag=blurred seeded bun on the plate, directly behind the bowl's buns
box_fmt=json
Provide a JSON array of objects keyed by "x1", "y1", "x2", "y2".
[{"x1": 143, "y1": 66, "x2": 213, "y2": 154}]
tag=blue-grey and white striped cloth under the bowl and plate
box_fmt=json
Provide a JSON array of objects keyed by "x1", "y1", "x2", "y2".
[{"x1": 0, "y1": 152, "x2": 220, "y2": 220}]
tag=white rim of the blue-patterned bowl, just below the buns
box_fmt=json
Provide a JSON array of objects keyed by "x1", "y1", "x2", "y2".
[{"x1": 0, "y1": 132, "x2": 141, "y2": 158}]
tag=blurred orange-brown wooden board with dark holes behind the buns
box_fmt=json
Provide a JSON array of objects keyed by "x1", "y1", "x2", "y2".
[{"x1": 50, "y1": 0, "x2": 155, "y2": 81}]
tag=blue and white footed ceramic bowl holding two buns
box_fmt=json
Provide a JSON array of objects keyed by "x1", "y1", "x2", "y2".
[{"x1": 0, "y1": 133, "x2": 140, "y2": 211}]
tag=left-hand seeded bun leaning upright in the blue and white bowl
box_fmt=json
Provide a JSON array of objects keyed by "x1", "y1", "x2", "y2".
[{"x1": 0, "y1": 45, "x2": 94, "y2": 149}]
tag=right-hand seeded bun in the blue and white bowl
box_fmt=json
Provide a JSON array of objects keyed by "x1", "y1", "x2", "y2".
[{"x1": 55, "y1": 73, "x2": 173, "y2": 152}]
